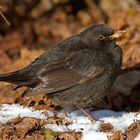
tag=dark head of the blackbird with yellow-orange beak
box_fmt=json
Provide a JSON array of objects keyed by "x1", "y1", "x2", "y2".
[{"x1": 79, "y1": 24, "x2": 125, "y2": 49}]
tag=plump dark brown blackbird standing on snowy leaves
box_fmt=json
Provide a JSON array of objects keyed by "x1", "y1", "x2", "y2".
[{"x1": 0, "y1": 24, "x2": 124, "y2": 108}]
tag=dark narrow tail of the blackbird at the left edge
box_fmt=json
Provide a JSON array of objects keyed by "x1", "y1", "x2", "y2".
[{"x1": 0, "y1": 70, "x2": 38, "y2": 87}]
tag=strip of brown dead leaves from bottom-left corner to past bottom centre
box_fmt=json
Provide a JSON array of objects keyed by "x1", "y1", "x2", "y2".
[{"x1": 0, "y1": 117, "x2": 82, "y2": 140}]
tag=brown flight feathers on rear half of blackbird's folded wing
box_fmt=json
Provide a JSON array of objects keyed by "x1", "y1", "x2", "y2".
[{"x1": 37, "y1": 60, "x2": 83, "y2": 93}]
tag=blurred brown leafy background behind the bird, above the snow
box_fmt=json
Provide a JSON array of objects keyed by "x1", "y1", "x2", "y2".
[{"x1": 0, "y1": 0, "x2": 140, "y2": 111}]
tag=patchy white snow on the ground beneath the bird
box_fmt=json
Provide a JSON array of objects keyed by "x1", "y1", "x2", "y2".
[{"x1": 0, "y1": 104, "x2": 140, "y2": 140}]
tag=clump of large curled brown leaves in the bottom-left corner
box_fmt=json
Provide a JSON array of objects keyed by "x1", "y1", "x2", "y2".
[{"x1": 0, "y1": 118, "x2": 44, "y2": 140}]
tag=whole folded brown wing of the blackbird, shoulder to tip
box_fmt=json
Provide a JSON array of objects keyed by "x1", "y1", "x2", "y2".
[{"x1": 30, "y1": 50, "x2": 104, "y2": 93}]
